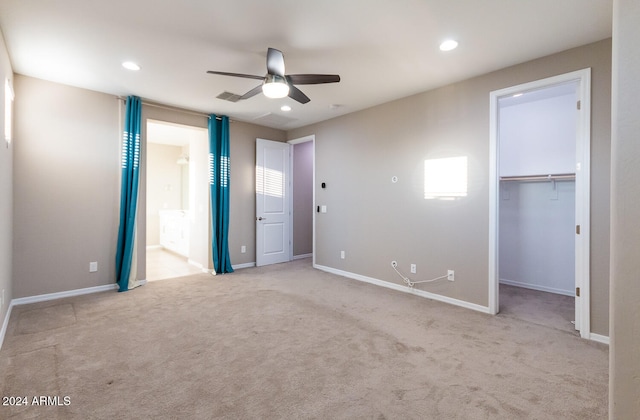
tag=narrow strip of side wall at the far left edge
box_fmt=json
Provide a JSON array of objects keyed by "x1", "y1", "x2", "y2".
[{"x1": 0, "y1": 32, "x2": 15, "y2": 332}]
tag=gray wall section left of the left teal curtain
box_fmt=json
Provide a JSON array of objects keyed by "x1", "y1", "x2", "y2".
[{"x1": 13, "y1": 75, "x2": 121, "y2": 298}]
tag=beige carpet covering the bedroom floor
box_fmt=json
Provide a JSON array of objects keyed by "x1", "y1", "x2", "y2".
[{"x1": 0, "y1": 260, "x2": 608, "y2": 420}]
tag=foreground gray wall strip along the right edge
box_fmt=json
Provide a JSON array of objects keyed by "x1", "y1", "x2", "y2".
[{"x1": 609, "y1": 0, "x2": 640, "y2": 419}]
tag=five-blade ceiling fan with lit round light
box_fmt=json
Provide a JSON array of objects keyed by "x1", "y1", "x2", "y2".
[{"x1": 207, "y1": 48, "x2": 340, "y2": 104}]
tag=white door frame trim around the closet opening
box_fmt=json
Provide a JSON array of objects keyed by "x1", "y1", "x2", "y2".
[{"x1": 489, "y1": 68, "x2": 591, "y2": 338}]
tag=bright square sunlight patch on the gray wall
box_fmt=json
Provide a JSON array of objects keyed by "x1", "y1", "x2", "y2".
[{"x1": 424, "y1": 156, "x2": 467, "y2": 200}]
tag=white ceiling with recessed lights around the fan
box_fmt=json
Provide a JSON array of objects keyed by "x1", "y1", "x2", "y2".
[{"x1": 0, "y1": 0, "x2": 612, "y2": 130}]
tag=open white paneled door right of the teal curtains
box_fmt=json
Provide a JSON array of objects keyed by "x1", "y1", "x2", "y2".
[{"x1": 256, "y1": 139, "x2": 291, "y2": 266}]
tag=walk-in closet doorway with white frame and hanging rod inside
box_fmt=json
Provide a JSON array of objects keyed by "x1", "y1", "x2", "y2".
[{"x1": 489, "y1": 69, "x2": 590, "y2": 337}]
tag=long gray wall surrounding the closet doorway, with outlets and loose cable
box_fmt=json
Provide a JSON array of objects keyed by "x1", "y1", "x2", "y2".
[{"x1": 288, "y1": 40, "x2": 611, "y2": 335}]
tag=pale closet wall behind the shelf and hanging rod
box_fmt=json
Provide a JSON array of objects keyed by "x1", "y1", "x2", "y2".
[{"x1": 499, "y1": 83, "x2": 577, "y2": 296}]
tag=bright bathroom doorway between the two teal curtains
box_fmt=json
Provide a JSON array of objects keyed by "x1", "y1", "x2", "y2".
[{"x1": 146, "y1": 120, "x2": 209, "y2": 281}]
